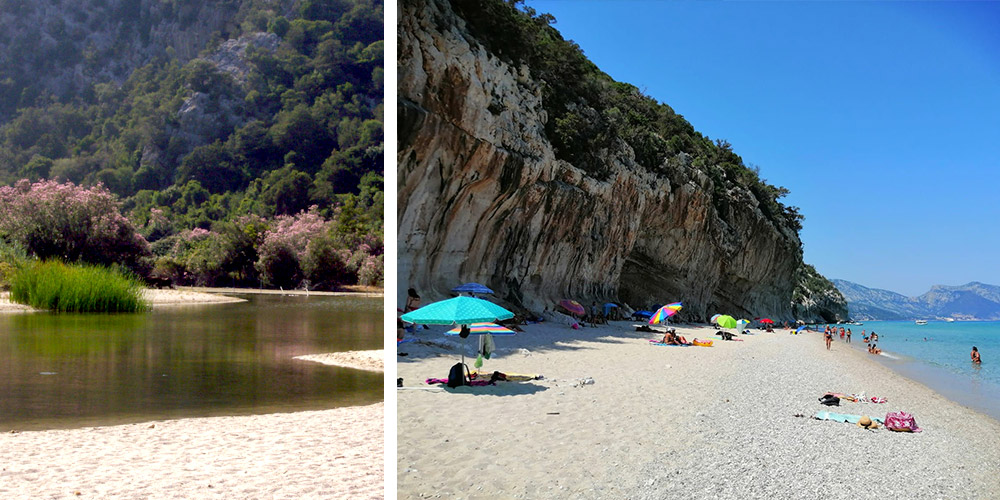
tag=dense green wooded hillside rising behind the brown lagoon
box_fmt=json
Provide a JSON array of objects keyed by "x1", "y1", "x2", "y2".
[{"x1": 0, "y1": 0, "x2": 384, "y2": 287}]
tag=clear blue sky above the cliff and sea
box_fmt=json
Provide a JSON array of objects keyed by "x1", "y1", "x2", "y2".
[{"x1": 527, "y1": 0, "x2": 1000, "y2": 295}]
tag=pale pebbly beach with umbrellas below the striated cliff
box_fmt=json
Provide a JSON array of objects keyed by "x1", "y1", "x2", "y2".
[{"x1": 397, "y1": 322, "x2": 1000, "y2": 499}]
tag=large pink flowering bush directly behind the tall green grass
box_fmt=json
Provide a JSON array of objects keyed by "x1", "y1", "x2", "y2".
[{"x1": 0, "y1": 179, "x2": 150, "y2": 275}]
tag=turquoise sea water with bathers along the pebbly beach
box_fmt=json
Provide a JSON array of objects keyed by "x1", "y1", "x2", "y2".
[{"x1": 835, "y1": 321, "x2": 1000, "y2": 420}]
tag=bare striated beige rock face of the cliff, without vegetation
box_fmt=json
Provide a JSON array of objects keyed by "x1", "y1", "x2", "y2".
[{"x1": 397, "y1": 0, "x2": 802, "y2": 320}]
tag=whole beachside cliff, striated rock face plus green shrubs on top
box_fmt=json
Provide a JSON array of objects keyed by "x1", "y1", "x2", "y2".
[{"x1": 397, "y1": 0, "x2": 847, "y2": 321}]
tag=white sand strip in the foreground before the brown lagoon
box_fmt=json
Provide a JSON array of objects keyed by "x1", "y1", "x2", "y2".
[{"x1": 0, "y1": 403, "x2": 384, "y2": 500}]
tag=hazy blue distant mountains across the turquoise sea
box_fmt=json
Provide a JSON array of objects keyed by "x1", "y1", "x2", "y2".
[{"x1": 832, "y1": 279, "x2": 1000, "y2": 321}]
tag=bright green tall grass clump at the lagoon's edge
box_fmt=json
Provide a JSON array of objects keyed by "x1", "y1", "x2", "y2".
[{"x1": 10, "y1": 261, "x2": 149, "y2": 312}]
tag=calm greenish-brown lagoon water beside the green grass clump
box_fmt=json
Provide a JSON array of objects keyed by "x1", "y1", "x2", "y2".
[{"x1": 0, "y1": 295, "x2": 383, "y2": 431}]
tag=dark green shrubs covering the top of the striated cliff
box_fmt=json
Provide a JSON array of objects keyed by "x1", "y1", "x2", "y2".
[{"x1": 451, "y1": 0, "x2": 802, "y2": 230}]
